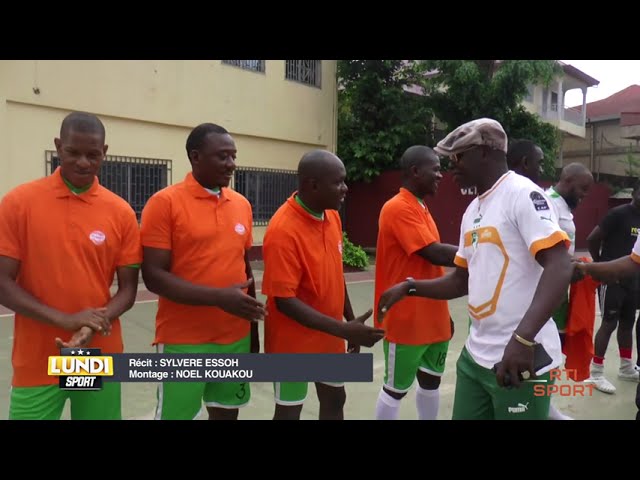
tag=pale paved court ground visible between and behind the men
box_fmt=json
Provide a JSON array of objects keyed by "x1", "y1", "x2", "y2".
[{"x1": 0, "y1": 262, "x2": 636, "y2": 420}]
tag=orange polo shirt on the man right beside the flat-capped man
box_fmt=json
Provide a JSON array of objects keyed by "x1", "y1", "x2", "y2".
[{"x1": 374, "y1": 188, "x2": 451, "y2": 345}]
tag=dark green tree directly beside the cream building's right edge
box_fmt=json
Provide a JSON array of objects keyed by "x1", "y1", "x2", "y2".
[{"x1": 338, "y1": 60, "x2": 432, "y2": 181}]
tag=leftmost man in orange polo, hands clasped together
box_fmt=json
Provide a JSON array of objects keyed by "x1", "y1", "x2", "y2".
[{"x1": 0, "y1": 112, "x2": 142, "y2": 420}]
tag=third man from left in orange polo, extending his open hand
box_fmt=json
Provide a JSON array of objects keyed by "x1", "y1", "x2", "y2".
[{"x1": 262, "y1": 150, "x2": 384, "y2": 420}]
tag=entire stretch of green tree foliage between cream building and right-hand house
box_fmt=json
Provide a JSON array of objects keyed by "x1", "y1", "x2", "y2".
[{"x1": 338, "y1": 60, "x2": 560, "y2": 181}]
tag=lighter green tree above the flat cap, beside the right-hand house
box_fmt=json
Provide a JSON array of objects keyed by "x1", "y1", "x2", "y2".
[{"x1": 422, "y1": 60, "x2": 561, "y2": 178}]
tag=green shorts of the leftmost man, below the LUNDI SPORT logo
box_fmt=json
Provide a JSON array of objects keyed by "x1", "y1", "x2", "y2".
[{"x1": 9, "y1": 381, "x2": 122, "y2": 420}]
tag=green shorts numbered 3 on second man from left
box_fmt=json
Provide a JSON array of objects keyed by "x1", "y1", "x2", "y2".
[{"x1": 155, "y1": 335, "x2": 251, "y2": 420}]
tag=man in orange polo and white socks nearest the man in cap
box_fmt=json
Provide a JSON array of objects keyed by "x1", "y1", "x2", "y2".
[{"x1": 375, "y1": 145, "x2": 458, "y2": 420}]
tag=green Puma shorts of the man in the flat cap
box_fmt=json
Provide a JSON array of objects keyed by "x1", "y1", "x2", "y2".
[{"x1": 453, "y1": 347, "x2": 554, "y2": 420}]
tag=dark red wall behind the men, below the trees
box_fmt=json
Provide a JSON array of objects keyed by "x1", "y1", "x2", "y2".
[{"x1": 345, "y1": 171, "x2": 624, "y2": 250}]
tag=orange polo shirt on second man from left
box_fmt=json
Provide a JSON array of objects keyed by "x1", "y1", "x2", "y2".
[{"x1": 141, "y1": 173, "x2": 253, "y2": 344}]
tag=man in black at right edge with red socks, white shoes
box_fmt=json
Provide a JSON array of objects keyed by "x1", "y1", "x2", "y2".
[{"x1": 587, "y1": 181, "x2": 640, "y2": 393}]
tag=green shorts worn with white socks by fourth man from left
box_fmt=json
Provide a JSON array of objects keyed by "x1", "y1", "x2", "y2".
[{"x1": 382, "y1": 338, "x2": 449, "y2": 393}]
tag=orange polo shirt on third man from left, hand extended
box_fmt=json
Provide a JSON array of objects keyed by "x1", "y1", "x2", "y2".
[{"x1": 262, "y1": 193, "x2": 345, "y2": 353}]
